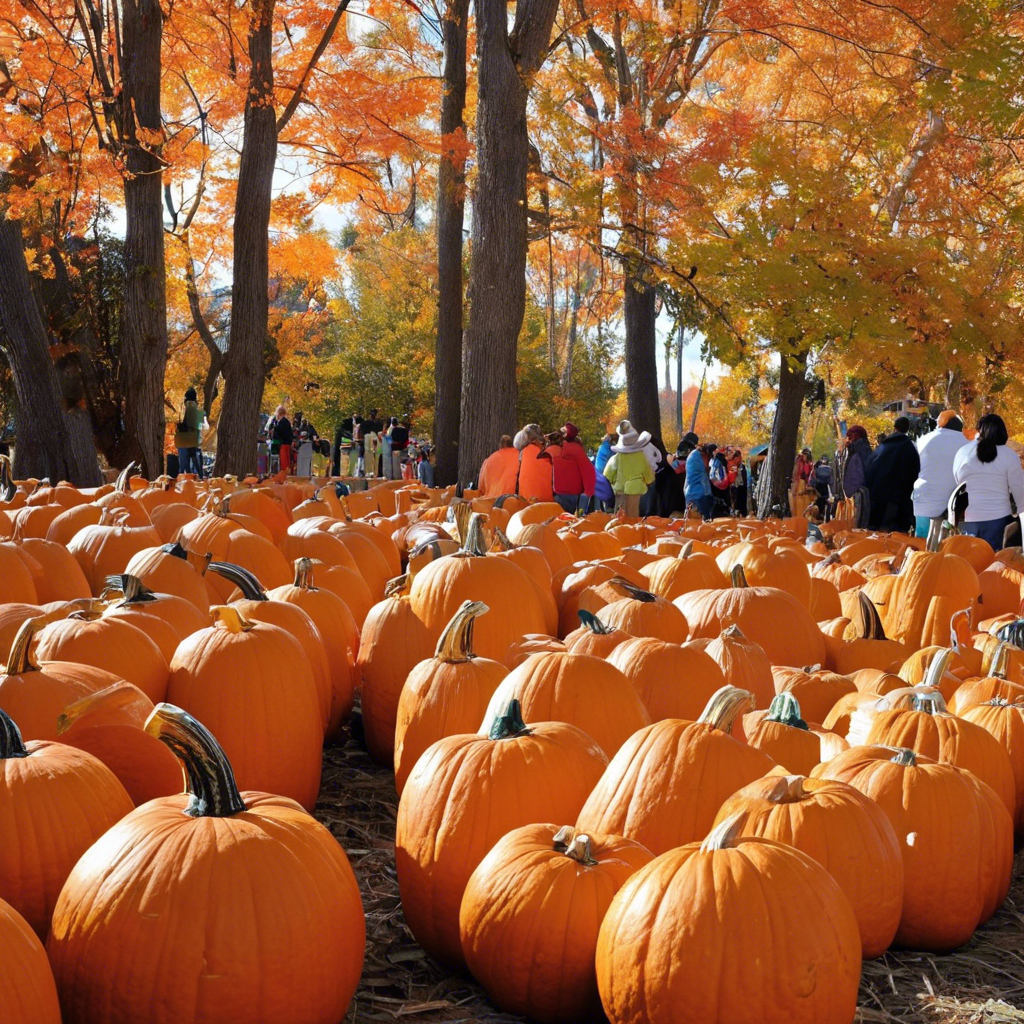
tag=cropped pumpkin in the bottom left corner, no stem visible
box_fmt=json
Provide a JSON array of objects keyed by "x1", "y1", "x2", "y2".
[{"x1": 0, "y1": 899, "x2": 60, "y2": 1024}]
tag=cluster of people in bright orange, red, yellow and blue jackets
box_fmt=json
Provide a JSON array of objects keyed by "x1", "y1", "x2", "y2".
[{"x1": 477, "y1": 420, "x2": 748, "y2": 518}]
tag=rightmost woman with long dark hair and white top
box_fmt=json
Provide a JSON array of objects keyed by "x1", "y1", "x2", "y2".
[{"x1": 953, "y1": 413, "x2": 1024, "y2": 551}]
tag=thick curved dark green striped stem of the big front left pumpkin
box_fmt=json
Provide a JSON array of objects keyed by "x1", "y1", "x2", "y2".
[{"x1": 145, "y1": 703, "x2": 246, "y2": 818}]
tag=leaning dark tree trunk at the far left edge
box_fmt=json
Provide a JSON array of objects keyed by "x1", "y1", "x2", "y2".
[{"x1": 0, "y1": 217, "x2": 102, "y2": 487}]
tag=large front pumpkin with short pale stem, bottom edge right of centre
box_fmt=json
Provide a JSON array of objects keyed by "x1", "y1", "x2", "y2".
[{"x1": 597, "y1": 819, "x2": 861, "y2": 1024}]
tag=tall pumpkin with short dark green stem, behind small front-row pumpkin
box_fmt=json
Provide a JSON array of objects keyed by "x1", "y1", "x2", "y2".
[{"x1": 395, "y1": 700, "x2": 606, "y2": 966}]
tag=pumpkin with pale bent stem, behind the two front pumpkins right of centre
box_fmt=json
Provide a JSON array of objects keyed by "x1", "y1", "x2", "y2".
[{"x1": 577, "y1": 686, "x2": 774, "y2": 854}]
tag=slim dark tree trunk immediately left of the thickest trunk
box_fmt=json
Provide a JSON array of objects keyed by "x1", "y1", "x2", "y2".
[{"x1": 434, "y1": 0, "x2": 469, "y2": 486}]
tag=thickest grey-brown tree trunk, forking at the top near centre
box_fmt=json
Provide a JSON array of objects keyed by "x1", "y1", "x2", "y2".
[{"x1": 459, "y1": 0, "x2": 558, "y2": 482}]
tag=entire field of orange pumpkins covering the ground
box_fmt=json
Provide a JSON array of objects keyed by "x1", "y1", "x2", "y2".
[{"x1": 0, "y1": 467, "x2": 1024, "y2": 1024}]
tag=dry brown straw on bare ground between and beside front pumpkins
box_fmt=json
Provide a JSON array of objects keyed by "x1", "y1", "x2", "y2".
[{"x1": 316, "y1": 740, "x2": 1024, "y2": 1024}]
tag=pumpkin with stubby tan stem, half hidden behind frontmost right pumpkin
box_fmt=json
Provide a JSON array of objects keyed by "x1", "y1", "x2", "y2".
[{"x1": 715, "y1": 773, "x2": 903, "y2": 958}]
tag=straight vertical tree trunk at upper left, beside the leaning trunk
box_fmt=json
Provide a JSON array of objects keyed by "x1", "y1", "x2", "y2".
[{"x1": 121, "y1": 0, "x2": 167, "y2": 479}]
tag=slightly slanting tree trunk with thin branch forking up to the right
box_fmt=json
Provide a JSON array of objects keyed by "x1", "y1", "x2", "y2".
[{"x1": 215, "y1": 0, "x2": 278, "y2": 476}]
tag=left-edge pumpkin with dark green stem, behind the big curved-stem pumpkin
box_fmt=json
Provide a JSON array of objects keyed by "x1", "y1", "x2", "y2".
[{"x1": 0, "y1": 711, "x2": 132, "y2": 938}]
